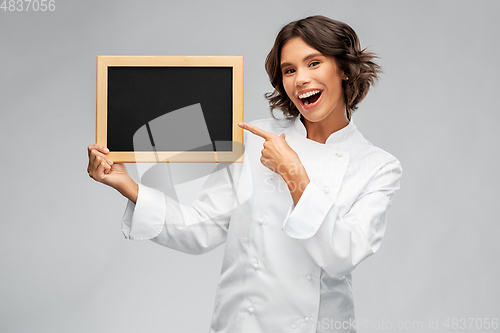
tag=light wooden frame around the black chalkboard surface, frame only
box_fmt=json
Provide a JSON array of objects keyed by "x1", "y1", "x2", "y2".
[{"x1": 96, "y1": 56, "x2": 243, "y2": 163}]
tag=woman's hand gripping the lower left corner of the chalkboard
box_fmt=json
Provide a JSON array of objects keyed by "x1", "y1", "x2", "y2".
[{"x1": 87, "y1": 144, "x2": 138, "y2": 202}]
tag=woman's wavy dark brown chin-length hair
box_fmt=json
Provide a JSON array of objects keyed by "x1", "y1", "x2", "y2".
[{"x1": 264, "y1": 15, "x2": 382, "y2": 119}]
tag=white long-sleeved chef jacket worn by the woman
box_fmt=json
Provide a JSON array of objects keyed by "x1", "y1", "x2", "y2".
[{"x1": 122, "y1": 117, "x2": 402, "y2": 333}]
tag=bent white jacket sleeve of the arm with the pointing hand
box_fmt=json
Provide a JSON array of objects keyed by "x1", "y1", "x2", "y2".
[{"x1": 283, "y1": 160, "x2": 402, "y2": 277}]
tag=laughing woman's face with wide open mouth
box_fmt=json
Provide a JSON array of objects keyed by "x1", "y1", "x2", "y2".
[{"x1": 281, "y1": 37, "x2": 345, "y2": 122}]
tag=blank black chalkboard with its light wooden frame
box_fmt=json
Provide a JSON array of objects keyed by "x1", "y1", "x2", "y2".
[{"x1": 96, "y1": 56, "x2": 243, "y2": 163}]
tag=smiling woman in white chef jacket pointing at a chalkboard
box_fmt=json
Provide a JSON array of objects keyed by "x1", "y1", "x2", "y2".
[{"x1": 88, "y1": 16, "x2": 402, "y2": 333}]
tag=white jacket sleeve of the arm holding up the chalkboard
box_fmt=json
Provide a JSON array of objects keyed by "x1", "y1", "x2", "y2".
[{"x1": 122, "y1": 163, "x2": 241, "y2": 254}]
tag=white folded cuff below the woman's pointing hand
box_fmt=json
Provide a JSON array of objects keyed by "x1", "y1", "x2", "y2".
[{"x1": 282, "y1": 182, "x2": 334, "y2": 239}]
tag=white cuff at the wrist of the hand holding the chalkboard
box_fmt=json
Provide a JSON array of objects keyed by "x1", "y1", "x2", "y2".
[{"x1": 122, "y1": 184, "x2": 167, "y2": 240}]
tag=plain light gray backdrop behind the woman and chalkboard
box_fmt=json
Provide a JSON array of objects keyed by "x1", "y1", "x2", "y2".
[{"x1": 0, "y1": 0, "x2": 500, "y2": 332}]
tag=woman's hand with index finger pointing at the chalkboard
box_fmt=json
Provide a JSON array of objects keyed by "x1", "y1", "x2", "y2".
[{"x1": 238, "y1": 123, "x2": 304, "y2": 177}]
